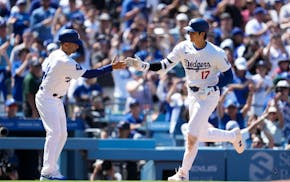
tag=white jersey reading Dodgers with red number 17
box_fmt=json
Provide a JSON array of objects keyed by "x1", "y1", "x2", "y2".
[{"x1": 167, "y1": 40, "x2": 231, "y2": 87}]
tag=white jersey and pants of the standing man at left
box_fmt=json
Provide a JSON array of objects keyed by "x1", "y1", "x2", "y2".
[{"x1": 35, "y1": 49, "x2": 86, "y2": 175}]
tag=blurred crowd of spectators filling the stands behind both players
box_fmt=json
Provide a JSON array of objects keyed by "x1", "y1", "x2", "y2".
[{"x1": 0, "y1": 0, "x2": 290, "y2": 179}]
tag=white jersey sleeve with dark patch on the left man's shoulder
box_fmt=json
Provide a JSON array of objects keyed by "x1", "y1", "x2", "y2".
[{"x1": 65, "y1": 59, "x2": 86, "y2": 79}]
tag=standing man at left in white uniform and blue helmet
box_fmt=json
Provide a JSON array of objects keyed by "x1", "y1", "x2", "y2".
[{"x1": 35, "y1": 29, "x2": 126, "y2": 180}]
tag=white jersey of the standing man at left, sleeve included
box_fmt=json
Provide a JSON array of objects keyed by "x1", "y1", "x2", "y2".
[{"x1": 40, "y1": 49, "x2": 86, "y2": 96}]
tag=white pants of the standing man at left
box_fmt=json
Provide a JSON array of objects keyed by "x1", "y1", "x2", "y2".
[{"x1": 35, "y1": 90, "x2": 67, "y2": 175}]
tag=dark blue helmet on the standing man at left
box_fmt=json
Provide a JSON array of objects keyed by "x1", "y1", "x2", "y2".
[{"x1": 58, "y1": 29, "x2": 82, "y2": 45}]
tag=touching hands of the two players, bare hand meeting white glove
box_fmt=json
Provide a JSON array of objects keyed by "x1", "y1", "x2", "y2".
[{"x1": 112, "y1": 56, "x2": 149, "y2": 71}]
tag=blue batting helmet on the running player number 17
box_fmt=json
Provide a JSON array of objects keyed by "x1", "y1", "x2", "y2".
[{"x1": 184, "y1": 18, "x2": 209, "y2": 33}]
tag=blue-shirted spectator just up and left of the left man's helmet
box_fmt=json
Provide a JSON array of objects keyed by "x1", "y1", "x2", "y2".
[{"x1": 30, "y1": 0, "x2": 55, "y2": 42}]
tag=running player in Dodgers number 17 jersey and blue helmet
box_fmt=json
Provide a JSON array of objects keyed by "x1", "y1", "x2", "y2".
[{"x1": 125, "y1": 18, "x2": 244, "y2": 181}]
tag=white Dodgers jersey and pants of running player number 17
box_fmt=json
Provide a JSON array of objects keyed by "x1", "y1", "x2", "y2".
[{"x1": 162, "y1": 41, "x2": 235, "y2": 171}]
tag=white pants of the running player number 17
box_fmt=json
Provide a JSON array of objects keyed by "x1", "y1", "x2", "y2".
[{"x1": 182, "y1": 90, "x2": 235, "y2": 172}]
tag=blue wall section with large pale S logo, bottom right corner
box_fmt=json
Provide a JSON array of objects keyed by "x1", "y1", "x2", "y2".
[{"x1": 226, "y1": 150, "x2": 290, "y2": 181}]
